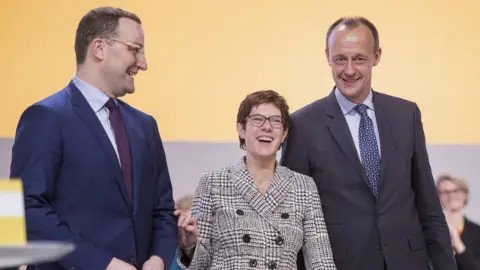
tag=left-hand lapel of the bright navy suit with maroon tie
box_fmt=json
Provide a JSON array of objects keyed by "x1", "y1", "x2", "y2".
[{"x1": 66, "y1": 82, "x2": 130, "y2": 208}]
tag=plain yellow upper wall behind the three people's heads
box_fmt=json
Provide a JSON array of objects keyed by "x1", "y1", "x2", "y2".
[{"x1": 0, "y1": 0, "x2": 480, "y2": 144}]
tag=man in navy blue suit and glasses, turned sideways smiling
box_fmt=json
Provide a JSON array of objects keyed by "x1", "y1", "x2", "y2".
[{"x1": 11, "y1": 7, "x2": 177, "y2": 270}]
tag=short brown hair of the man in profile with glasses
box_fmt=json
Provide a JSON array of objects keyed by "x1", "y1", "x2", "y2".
[{"x1": 75, "y1": 7, "x2": 142, "y2": 65}]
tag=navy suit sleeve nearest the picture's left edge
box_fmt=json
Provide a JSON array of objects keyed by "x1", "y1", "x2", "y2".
[{"x1": 10, "y1": 105, "x2": 113, "y2": 269}]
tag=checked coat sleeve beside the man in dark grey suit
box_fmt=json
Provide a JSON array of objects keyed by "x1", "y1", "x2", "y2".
[{"x1": 302, "y1": 177, "x2": 337, "y2": 270}]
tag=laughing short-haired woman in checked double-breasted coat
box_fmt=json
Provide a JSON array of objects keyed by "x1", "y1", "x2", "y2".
[{"x1": 176, "y1": 90, "x2": 336, "y2": 270}]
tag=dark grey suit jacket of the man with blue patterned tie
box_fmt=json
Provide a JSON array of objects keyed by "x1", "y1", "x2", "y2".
[{"x1": 282, "y1": 91, "x2": 457, "y2": 270}]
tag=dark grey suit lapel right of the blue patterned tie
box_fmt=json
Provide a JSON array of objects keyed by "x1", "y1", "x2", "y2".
[{"x1": 373, "y1": 92, "x2": 397, "y2": 189}]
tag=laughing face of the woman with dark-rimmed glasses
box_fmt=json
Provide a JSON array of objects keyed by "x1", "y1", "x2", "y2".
[{"x1": 237, "y1": 103, "x2": 287, "y2": 159}]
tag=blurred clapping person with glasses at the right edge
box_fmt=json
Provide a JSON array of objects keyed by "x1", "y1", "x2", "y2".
[{"x1": 437, "y1": 174, "x2": 480, "y2": 270}]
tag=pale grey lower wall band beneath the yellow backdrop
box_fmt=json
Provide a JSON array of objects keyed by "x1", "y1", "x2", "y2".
[{"x1": 0, "y1": 138, "x2": 480, "y2": 222}]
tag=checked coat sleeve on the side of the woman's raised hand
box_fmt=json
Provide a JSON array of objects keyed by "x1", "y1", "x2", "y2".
[{"x1": 178, "y1": 173, "x2": 213, "y2": 270}]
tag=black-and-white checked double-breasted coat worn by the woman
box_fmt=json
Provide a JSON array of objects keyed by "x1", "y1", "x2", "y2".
[{"x1": 177, "y1": 159, "x2": 336, "y2": 270}]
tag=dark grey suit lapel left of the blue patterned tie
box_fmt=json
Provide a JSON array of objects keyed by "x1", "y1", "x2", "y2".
[{"x1": 326, "y1": 91, "x2": 373, "y2": 195}]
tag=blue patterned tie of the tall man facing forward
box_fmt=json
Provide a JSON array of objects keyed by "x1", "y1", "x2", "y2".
[{"x1": 354, "y1": 104, "x2": 380, "y2": 198}]
